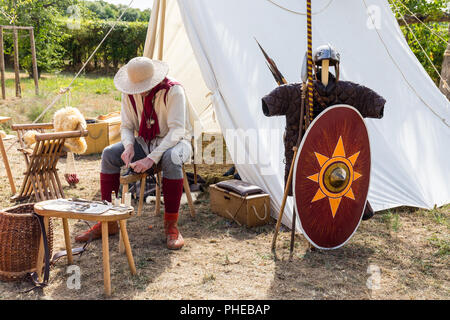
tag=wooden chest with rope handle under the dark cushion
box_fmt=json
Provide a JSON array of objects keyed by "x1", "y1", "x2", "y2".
[{"x1": 209, "y1": 185, "x2": 270, "y2": 227}]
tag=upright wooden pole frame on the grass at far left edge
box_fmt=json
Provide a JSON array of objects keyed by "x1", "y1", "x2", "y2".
[{"x1": 0, "y1": 26, "x2": 39, "y2": 99}]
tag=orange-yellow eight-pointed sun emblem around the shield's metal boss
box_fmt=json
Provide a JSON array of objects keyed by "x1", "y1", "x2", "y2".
[{"x1": 308, "y1": 137, "x2": 362, "y2": 218}]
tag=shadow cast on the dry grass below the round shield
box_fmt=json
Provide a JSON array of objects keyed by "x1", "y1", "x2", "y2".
[{"x1": 267, "y1": 239, "x2": 374, "y2": 300}]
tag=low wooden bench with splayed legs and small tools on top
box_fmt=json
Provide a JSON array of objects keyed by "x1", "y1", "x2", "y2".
[{"x1": 34, "y1": 200, "x2": 136, "y2": 296}]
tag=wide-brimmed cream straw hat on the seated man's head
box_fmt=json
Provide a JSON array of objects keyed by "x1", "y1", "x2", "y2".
[{"x1": 114, "y1": 57, "x2": 169, "y2": 94}]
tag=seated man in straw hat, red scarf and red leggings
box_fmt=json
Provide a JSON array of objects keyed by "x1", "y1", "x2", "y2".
[{"x1": 76, "y1": 57, "x2": 194, "y2": 250}]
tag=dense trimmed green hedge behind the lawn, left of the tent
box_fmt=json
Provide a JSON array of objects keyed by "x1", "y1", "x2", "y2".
[{"x1": 0, "y1": 19, "x2": 147, "y2": 76}]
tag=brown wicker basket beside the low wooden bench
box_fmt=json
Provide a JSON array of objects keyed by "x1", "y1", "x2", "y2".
[{"x1": 0, "y1": 204, "x2": 53, "y2": 281}]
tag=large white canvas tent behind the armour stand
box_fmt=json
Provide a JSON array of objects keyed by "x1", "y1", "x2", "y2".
[{"x1": 145, "y1": 0, "x2": 450, "y2": 225}]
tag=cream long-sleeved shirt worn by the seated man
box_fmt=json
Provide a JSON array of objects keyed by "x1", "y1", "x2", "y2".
[{"x1": 121, "y1": 85, "x2": 193, "y2": 164}]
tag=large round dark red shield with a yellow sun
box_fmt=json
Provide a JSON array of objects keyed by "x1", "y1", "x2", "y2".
[{"x1": 293, "y1": 105, "x2": 370, "y2": 249}]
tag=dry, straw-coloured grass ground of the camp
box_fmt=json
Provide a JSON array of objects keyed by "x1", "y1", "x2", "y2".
[{"x1": 0, "y1": 72, "x2": 450, "y2": 300}]
